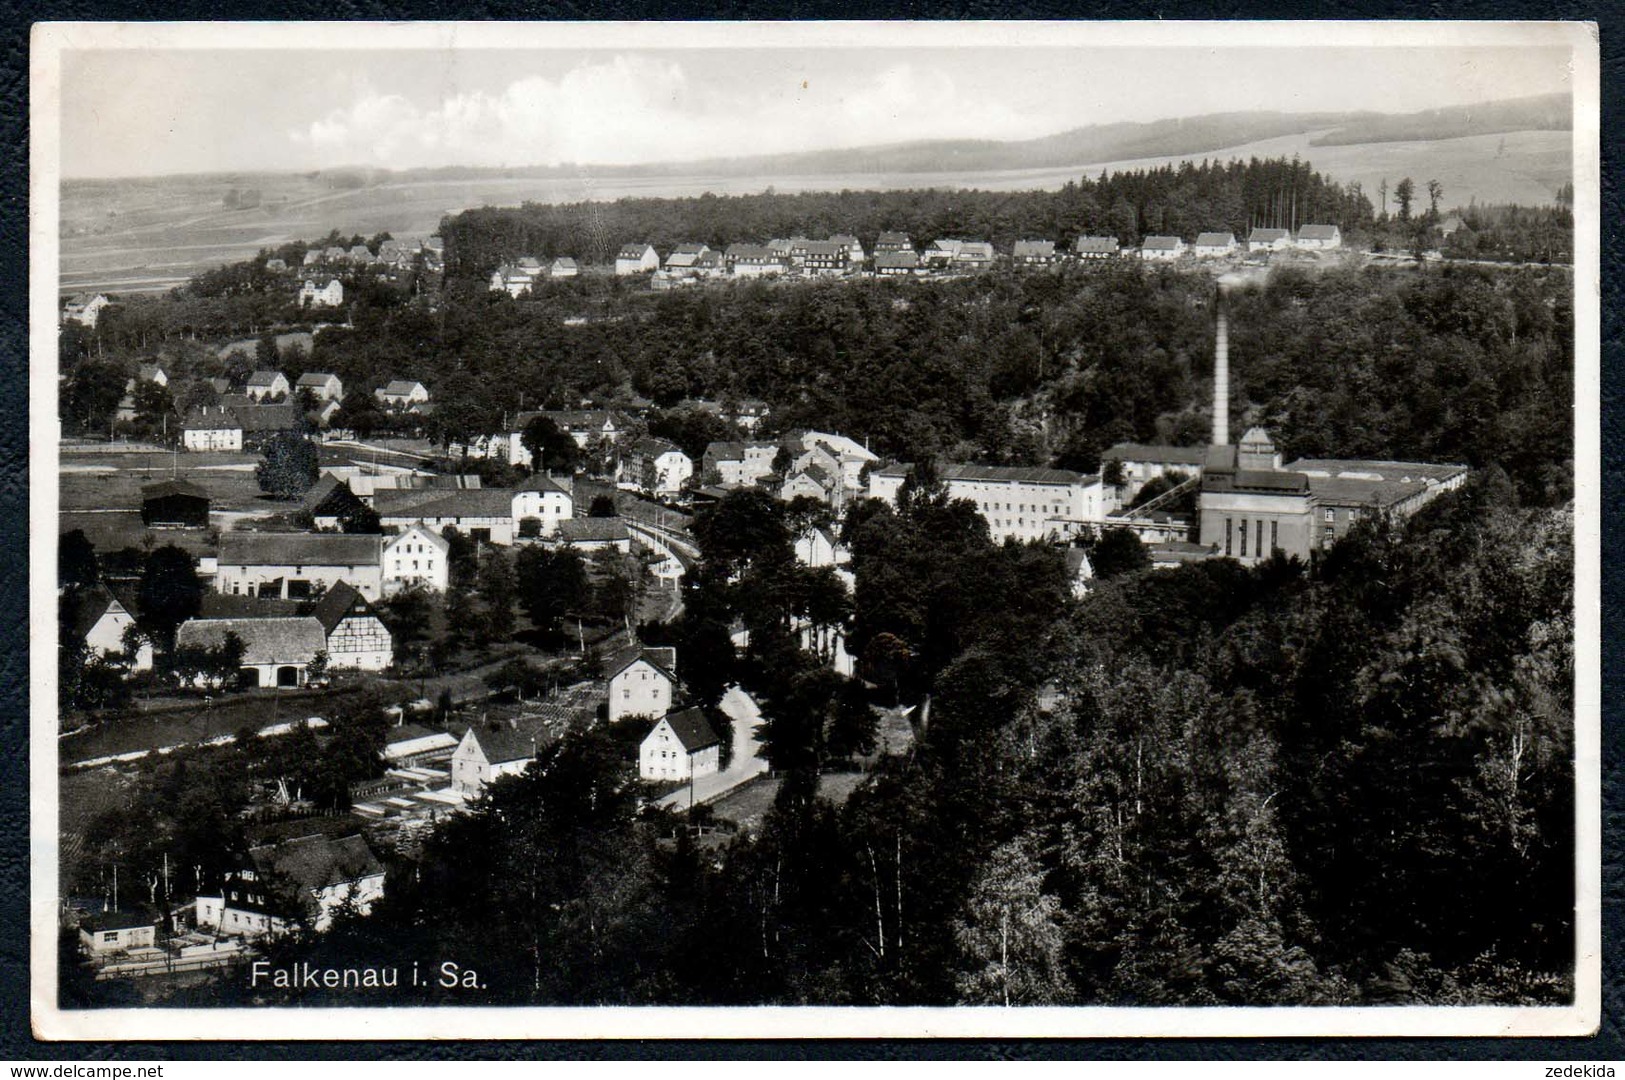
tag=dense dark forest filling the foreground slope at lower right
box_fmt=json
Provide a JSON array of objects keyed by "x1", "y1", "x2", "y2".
[{"x1": 161, "y1": 469, "x2": 1573, "y2": 1005}]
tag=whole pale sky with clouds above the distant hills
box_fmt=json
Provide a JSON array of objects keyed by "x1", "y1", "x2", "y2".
[{"x1": 60, "y1": 34, "x2": 1570, "y2": 179}]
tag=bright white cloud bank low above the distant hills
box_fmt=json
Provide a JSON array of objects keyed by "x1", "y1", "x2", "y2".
[{"x1": 291, "y1": 55, "x2": 1056, "y2": 167}]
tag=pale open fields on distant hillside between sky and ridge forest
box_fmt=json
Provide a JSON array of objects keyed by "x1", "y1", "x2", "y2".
[{"x1": 60, "y1": 132, "x2": 1573, "y2": 292}]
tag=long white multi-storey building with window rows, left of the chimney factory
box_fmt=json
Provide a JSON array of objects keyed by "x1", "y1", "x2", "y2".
[{"x1": 869, "y1": 464, "x2": 1105, "y2": 544}]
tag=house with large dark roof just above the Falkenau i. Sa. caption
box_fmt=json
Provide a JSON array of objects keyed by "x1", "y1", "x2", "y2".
[{"x1": 197, "y1": 835, "x2": 384, "y2": 939}]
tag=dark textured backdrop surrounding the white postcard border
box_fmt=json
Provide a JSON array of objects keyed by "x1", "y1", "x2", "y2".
[{"x1": 0, "y1": 0, "x2": 1625, "y2": 1058}]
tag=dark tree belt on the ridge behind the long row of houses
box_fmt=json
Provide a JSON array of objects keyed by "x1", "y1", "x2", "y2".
[{"x1": 440, "y1": 158, "x2": 1373, "y2": 279}]
